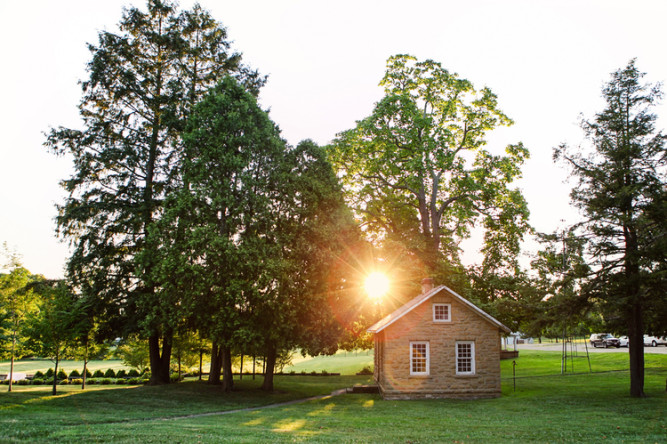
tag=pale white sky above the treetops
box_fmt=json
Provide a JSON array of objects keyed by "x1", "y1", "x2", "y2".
[{"x1": 0, "y1": 0, "x2": 667, "y2": 278}]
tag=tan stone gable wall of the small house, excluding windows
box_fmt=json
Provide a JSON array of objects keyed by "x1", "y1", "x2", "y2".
[{"x1": 376, "y1": 291, "x2": 500, "y2": 399}]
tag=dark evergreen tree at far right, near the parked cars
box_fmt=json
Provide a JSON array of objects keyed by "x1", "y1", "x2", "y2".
[{"x1": 554, "y1": 60, "x2": 667, "y2": 397}]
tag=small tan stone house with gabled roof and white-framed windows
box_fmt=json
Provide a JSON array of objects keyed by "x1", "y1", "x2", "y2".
[{"x1": 368, "y1": 279, "x2": 511, "y2": 399}]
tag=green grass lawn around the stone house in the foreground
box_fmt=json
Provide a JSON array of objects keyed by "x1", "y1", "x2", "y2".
[{"x1": 0, "y1": 351, "x2": 667, "y2": 443}]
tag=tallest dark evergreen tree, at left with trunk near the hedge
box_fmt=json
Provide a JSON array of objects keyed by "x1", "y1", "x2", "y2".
[{"x1": 46, "y1": 0, "x2": 263, "y2": 383}]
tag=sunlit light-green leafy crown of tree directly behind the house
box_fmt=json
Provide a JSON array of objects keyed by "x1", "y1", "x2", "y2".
[{"x1": 330, "y1": 55, "x2": 528, "y2": 279}]
